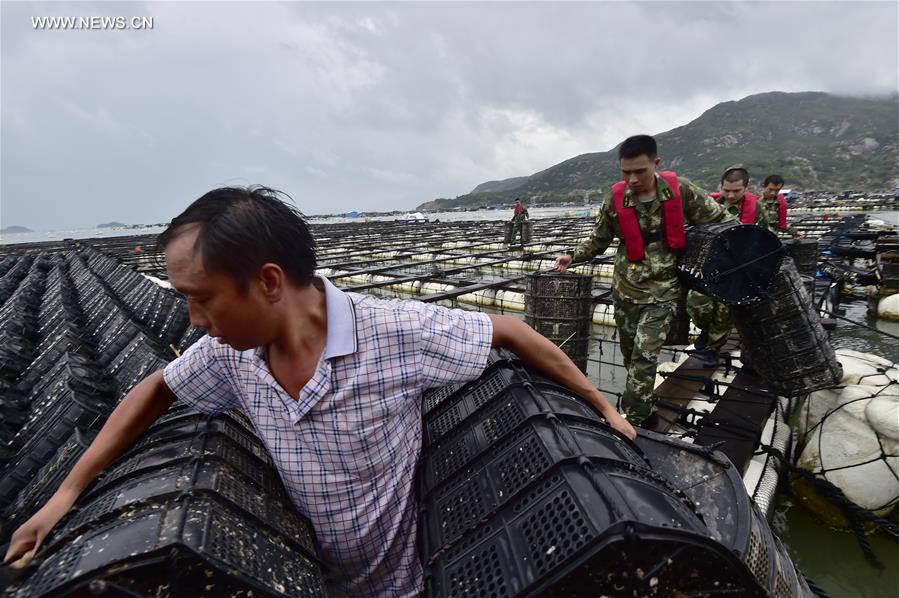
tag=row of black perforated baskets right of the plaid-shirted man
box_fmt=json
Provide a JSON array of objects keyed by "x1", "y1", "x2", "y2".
[{"x1": 418, "y1": 352, "x2": 809, "y2": 596}]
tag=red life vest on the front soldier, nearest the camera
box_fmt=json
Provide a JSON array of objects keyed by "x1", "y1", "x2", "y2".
[{"x1": 612, "y1": 171, "x2": 687, "y2": 262}]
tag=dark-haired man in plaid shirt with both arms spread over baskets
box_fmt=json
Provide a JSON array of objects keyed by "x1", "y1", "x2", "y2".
[{"x1": 7, "y1": 187, "x2": 635, "y2": 596}]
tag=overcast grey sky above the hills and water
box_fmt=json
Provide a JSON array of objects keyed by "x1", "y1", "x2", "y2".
[{"x1": 0, "y1": 1, "x2": 899, "y2": 230}]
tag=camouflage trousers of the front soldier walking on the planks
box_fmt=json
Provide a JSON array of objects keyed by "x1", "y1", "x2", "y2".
[{"x1": 615, "y1": 301, "x2": 677, "y2": 423}]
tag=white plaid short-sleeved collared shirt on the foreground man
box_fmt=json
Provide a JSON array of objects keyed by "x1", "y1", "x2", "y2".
[{"x1": 164, "y1": 278, "x2": 493, "y2": 596}]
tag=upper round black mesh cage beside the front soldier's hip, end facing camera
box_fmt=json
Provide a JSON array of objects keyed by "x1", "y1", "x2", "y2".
[{"x1": 677, "y1": 222, "x2": 783, "y2": 305}]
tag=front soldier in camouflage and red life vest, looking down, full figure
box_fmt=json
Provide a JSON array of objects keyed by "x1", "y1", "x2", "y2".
[{"x1": 555, "y1": 135, "x2": 731, "y2": 422}]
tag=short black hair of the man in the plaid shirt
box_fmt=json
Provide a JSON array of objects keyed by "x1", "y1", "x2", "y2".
[{"x1": 157, "y1": 185, "x2": 317, "y2": 291}]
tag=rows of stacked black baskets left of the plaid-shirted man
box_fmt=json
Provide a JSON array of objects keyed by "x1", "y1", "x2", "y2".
[{"x1": 0, "y1": 247, "x2": 327, "y2": 598}]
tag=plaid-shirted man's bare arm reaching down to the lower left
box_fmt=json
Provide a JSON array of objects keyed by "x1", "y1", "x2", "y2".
[{"x1": 4, "y1": 370, "x2": 175, "y2": 567}]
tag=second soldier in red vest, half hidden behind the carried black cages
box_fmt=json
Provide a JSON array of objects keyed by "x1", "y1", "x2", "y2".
[{"x1": 687, "y1": 164, "x2": 768, "y2": 368}]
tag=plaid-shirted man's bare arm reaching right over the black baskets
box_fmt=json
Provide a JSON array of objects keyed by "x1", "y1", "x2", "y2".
[{"x1": 489, "y1": 315, "x2": 637, "y2": 440}]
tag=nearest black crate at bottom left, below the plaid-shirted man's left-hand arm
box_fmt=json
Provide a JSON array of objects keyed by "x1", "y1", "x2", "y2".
[{"x1": 5, "y1": 493, "x2": 325, "y2": 597}]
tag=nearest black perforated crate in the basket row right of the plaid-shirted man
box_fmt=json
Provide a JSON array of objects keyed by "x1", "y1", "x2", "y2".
[{"x1": 426, "y1": 460, "x2": 759, "y2": 596}]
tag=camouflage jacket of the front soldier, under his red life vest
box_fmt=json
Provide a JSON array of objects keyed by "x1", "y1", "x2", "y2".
[{"x1": 573, "y1": 174, "x2": 733, "y2": 304}]
